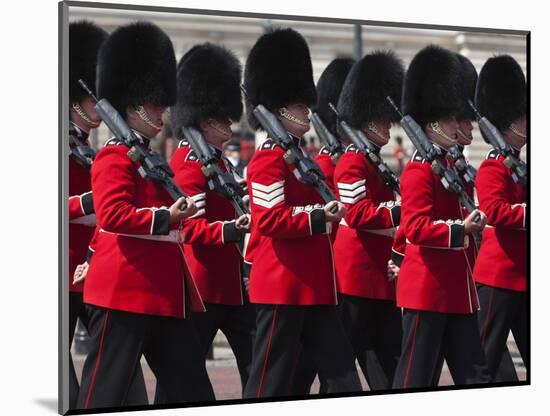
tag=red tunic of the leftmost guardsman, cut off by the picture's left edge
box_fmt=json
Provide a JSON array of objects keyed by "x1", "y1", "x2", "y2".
[{"x1": 69, "y1": 157, "x2": 95, "y2": 292}]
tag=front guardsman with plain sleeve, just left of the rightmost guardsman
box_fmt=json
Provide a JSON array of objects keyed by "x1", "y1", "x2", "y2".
[{"x1": 393, "y1": 45, "x2": 490, "y2": 388}]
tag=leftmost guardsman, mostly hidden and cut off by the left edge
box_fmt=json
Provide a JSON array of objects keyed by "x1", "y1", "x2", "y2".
[{"x1": 69, "y1": 20, "x2": 147, "y2": 408}]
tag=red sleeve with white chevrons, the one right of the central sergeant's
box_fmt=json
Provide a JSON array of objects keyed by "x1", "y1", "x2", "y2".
[{"x1": 334, "y1": 153, "x2": 401, "y2": 230}]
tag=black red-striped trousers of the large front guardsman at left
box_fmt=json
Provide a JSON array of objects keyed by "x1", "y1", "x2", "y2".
[{"x1": 78, "y1": 305, "x2": 214, "y2": 409}]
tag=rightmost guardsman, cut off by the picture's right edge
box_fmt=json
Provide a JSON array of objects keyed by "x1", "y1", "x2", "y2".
[{"x1": 474, "y1": 55, "x2": 529, "y2": 381}]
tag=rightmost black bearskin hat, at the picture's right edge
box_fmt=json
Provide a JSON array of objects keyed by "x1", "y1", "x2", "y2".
[{"x1": 476, "y1": 55, "x2": 527, "y2": 129}]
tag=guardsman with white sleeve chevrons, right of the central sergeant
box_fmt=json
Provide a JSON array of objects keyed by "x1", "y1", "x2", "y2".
[{"x1": 334, "y1": 51, "x2": 405, "y2": 390}]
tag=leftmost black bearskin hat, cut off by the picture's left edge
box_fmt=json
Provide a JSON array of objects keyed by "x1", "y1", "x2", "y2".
[{"x1": 69, "y1": 20, "x2": 108, "y2": 103}]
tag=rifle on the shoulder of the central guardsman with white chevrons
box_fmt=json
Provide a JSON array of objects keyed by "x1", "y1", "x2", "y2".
[{"x1": 241, "y1": 85, "x2": 338, "y2": 213}]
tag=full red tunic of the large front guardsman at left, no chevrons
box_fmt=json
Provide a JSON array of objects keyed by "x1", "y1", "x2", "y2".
[{"x1": 84, "y1": 139, "x2": 204, "y2": 318}]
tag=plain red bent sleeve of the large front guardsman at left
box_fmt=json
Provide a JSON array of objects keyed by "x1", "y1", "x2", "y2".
[{"x1": 92, "y1": 145, "x2": 170, "y2": 235}]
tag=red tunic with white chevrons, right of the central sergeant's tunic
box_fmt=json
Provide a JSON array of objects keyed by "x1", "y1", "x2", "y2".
[{"x1": 334, "y1": 145, "x2": 400, "y2": 300}]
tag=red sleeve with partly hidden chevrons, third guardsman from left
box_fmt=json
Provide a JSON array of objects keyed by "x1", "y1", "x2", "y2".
[{"x1": 170, "y1": 148, "x2": 242, "y2": 245}]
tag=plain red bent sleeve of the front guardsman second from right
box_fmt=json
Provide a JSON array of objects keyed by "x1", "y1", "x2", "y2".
[{"x1": 401, "y1": 162, "x2": 465, "y2": 248}]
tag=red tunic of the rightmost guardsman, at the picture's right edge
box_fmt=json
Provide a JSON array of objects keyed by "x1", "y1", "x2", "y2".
[{"x1": 474, "y1": 150, "x2": 527, "y2": 291}]
